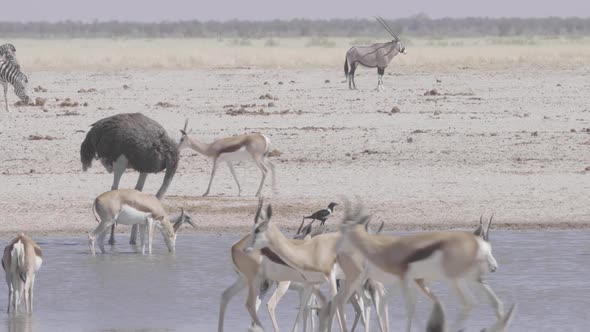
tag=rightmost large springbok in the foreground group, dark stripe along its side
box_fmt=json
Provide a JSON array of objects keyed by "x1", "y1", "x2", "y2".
[{"x1": 338, "y1": 203, "x2": 504, "y2": 331}]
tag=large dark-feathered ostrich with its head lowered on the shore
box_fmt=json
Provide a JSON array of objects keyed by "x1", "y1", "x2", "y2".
[{"x1": 80, "y1": 113, "x2": 179, "y2": 244}]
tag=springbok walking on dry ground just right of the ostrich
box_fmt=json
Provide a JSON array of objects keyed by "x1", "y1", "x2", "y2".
[{"x1": 178, "y1": 119, "x2": 276, "y2": 196}]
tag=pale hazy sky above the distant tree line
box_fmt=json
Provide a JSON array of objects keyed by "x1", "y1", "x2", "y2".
[{"x1": 0, "y1": 0, "x2": 590, "y2": 22}]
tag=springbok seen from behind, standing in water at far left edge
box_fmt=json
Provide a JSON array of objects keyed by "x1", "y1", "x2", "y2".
[{"x1": 2, "y1": 233, "x2": 43, "y2": 313}]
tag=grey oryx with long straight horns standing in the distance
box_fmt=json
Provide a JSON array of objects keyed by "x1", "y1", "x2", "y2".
[{"x1": 344, "y1": 16, "x2": 406, "y2": 91}]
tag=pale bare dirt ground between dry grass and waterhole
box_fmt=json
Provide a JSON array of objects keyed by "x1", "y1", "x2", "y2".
[{"x1": 0, "y1": 68, "x2": 590, "y2": 235}]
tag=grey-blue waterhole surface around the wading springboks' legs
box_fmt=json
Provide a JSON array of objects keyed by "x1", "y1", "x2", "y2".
[{"x1": 0, "y1": 231, "x2": 590, "y2": 332}]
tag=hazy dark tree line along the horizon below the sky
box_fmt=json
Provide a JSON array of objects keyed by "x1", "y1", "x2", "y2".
[{"x1": 0, "y1": 14, "x2": 590, "y2": 39}]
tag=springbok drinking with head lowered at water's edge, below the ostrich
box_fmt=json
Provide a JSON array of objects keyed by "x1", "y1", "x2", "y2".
[{"x1": 88, "y1": 189, "x2": 197, "y2": 256}]
